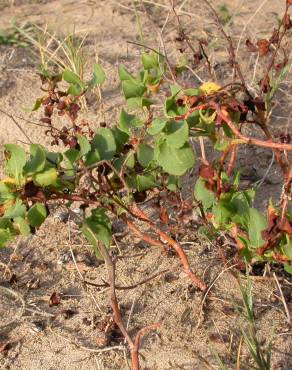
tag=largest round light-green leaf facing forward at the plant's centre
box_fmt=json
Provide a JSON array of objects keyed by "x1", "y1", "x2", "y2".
[{"x1": 157, "y1": 141, "x2": 195, "y2": 176}]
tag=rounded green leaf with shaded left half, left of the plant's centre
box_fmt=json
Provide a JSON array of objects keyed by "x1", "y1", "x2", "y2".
[{"x1": 91, "y1": 127, "x2": 117, "y2": 160}]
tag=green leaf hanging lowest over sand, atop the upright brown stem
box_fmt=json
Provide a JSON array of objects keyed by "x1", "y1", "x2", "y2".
[{"x1": 81, "y1": 208, "x2": 112, "y2": 258}]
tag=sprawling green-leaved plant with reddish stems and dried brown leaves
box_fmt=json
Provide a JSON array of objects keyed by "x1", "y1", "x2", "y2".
[{"x1": 0, "y1": 0, "x2": 292, "y2": 369}]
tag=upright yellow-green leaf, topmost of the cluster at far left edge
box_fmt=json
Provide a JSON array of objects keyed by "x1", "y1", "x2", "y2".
[{"x1": 5, "y1": 144, "x2": 26, "y2": 185}]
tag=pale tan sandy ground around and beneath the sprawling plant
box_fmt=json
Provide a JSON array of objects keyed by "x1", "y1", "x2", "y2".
[{"x1": 0, "y1": 0, "x2": 292, "y2": 370}]
